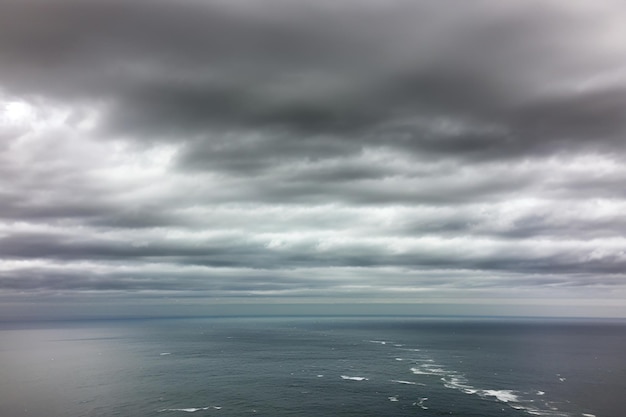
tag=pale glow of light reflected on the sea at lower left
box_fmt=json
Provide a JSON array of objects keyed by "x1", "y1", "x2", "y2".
[{"x1": 0, "y1": 326, "x2": 138, "y2": 417}]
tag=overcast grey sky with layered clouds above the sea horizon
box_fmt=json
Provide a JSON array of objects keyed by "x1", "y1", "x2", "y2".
[{"x1": 0, "y1": 0, "x2": 626, "y2": 319}]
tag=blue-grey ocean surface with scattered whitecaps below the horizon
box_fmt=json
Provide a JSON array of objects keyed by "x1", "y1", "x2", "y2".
[{"x1": 0, "y1": 317, "x2": 626, "y2": 417}]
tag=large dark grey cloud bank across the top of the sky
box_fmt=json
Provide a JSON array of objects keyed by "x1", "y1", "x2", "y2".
[{"x1": 0, "y1": 0, "x2": 626, "y2": 159}]
